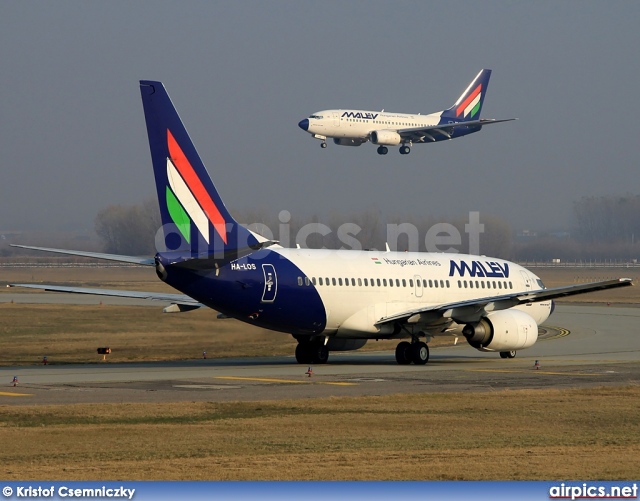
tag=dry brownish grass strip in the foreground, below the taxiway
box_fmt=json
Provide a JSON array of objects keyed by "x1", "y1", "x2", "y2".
[{"x1": 0, "y1": 387, "x2": 640, "y2": 480}]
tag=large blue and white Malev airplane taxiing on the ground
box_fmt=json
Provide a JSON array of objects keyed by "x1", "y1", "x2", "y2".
[{"x1": 11, "y1": 80, "x2": 631, "y2": 365}]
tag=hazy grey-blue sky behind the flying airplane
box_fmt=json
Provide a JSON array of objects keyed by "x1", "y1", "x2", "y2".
[{"x1": 0, "y1": 0, "x2": 640, "y2": 235}]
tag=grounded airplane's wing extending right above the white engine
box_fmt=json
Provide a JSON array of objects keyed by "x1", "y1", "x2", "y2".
[{"x1": 375, "y1": 278, "x2": 633, "y2": 326}]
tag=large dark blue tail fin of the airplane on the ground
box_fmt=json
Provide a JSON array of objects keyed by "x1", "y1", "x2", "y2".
[{"x1": 140, "y1": 80, "x2": 260, "y2": 261}]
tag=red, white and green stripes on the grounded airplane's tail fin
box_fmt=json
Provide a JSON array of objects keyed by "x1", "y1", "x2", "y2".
[{"x1": 166, "y1": 129, "x2": 227, "y2": 244}]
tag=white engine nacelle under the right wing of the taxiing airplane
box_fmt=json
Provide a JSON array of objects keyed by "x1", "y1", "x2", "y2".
[{"x1": 462, "y1": 310, "x2": 538, "y2": 351}]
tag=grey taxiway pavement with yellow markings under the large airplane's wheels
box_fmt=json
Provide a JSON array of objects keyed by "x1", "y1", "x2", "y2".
[{"x1": 0, "y1": 303, "x2": 640, "y2": 405}]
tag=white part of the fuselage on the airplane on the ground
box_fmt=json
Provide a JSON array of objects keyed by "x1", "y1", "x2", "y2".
[{"x1": 273, "y1": 248, "x2": 552, "y2": 338}]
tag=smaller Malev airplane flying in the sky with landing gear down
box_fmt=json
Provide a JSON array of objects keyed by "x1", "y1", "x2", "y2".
[{"x1": 298, "y1": 70, "x2": 516, "y2": 155}]
